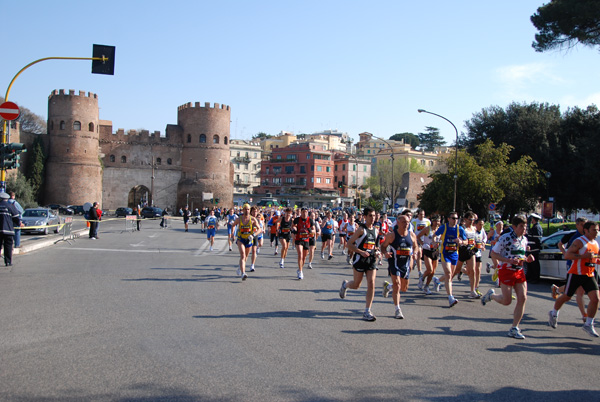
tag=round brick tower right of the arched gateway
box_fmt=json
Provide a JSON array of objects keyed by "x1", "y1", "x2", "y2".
[{"x1": 177, "y1": 102, "x2": 233, "y2": 208}]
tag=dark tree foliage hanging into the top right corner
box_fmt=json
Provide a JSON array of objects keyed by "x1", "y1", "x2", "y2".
[{"x1": 531, "y1": 0, "x2": 600, "y2": 52}]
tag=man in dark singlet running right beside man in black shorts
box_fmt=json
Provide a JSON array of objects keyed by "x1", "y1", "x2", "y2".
[{"x1": 381, "y1": 216, "x2": 418, "y2": 319}]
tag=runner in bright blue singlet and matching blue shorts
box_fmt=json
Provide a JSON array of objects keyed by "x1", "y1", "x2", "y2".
[{"x1": 433, "y1": 212, "x2": 467, "y2": 307}]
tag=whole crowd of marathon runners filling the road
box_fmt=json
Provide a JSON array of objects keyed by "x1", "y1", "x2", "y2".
[{"x1": 190, "y1": 204, "x2": 599, "y2": 339}]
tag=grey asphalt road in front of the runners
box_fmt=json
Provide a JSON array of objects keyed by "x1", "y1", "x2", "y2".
[{"x1": 0, "y1": 222, "x2": 600, "y2": 402}]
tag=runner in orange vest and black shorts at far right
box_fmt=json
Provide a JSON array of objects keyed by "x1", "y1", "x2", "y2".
[{"x1": 548, "y1": 221, "x2": 600, "y2": 338}]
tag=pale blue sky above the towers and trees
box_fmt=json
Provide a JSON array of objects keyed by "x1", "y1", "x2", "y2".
[{"x1": 0, "y1": 0, "x2": 600, "y2": 144}]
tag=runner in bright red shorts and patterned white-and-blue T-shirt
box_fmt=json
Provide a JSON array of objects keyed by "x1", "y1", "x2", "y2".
[{"x1": 481, "y1": 215, "x2": 533, "y2": 339}]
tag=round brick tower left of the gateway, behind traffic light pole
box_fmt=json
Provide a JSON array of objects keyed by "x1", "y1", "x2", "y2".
[{"x1": 45, "y1": 89, "x2": 102, "y2": 205}]
